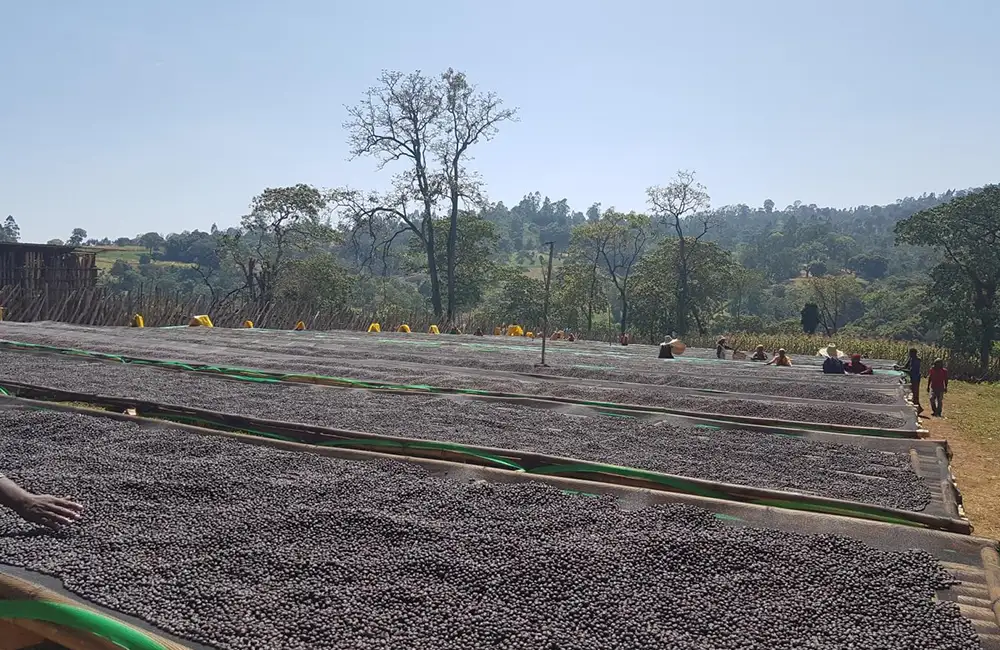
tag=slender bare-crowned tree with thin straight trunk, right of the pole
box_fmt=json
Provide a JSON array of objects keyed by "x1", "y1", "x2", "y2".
[{"x1": 646, "y1": 170, "x2": 718, "y2": 334}]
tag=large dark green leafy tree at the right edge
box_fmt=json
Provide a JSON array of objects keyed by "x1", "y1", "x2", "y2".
[{"x1": 895, "y1": 185, "x2": 1000, "y2": 373}]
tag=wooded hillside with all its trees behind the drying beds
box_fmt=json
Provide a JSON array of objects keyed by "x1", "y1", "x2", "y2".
[{"x1": 0, "y1": 70, "x2": 1000, "y2": 372}]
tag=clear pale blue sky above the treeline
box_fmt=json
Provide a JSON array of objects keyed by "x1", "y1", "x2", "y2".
[{"x1": 0, "y1": 0, "x2": 1000, "y2": 241}]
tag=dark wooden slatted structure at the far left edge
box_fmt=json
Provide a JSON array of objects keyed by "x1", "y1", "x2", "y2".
[{"x1": 0, "y1": 243, "x2": 97, "y2": 294}]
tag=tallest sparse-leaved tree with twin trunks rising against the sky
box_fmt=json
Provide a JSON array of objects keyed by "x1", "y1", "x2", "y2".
[{"x1": 342, "y1": 69, "x2": 516, "y2": 321}]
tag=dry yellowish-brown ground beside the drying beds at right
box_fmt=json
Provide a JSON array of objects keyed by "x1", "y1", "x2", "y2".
[{"x1": 920, "y1": 382, "x2": 1000, "y2": 539}]
